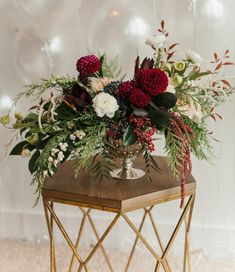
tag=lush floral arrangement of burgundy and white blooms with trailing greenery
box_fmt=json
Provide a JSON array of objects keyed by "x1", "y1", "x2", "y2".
[{"x1": 0, "y1": 21, "x2": 234, "y2": 206}]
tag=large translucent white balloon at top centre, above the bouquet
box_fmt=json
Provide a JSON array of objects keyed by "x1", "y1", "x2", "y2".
[{"x1": 79, "y1": 0, "x2": 157, "y2": 75}]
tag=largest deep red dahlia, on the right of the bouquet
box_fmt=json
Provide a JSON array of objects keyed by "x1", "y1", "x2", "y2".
[{"x1": 137, "y1": 69, "x2": 168, "y2": 95}]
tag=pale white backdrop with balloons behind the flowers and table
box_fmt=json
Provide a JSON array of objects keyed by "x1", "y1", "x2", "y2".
[{"x1": 0, "y1": 0, "x2": 235, "y2": 271}]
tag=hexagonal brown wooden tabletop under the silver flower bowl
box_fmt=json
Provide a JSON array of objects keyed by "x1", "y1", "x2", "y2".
[{"x1": 42, "y1": 157, "x2": 196, "y2": 211}]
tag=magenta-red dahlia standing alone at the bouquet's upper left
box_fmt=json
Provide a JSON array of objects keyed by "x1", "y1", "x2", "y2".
[{"x1": 77, "y1": 55, "x2": 100, "y2": 76}]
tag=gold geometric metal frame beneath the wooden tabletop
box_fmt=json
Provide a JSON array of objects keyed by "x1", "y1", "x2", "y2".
[{"x1": 43, "y1": 191, "x2": 195, "y2": 272}]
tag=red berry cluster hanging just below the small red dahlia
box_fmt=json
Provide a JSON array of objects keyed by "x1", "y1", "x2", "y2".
[{"x1": 130, "y1": 116, "x2": 157, "y2": 152}]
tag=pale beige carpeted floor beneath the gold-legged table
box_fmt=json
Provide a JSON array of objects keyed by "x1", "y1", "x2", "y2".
[{"x1": 0, "y1": 240, "x2": 235, "y2": 272}]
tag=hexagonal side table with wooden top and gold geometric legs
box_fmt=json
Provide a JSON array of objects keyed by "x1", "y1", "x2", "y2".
[{"x1": 42, "y1": 157, "x2": 196, "y2": 272}]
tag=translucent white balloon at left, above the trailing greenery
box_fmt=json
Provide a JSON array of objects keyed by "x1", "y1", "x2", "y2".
[{"x1": 13, "y1": 28, "x2": 63, "y2": 83}]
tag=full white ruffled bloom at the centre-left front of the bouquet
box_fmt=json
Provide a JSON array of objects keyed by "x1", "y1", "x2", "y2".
[{"x1": 92, "y1": 92, "x2": 119, "y2": 118}]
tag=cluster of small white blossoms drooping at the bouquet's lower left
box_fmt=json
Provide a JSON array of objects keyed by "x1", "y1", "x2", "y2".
[{"x1": 43, "y1": 142, "x2": 68, "y2": 177}]
